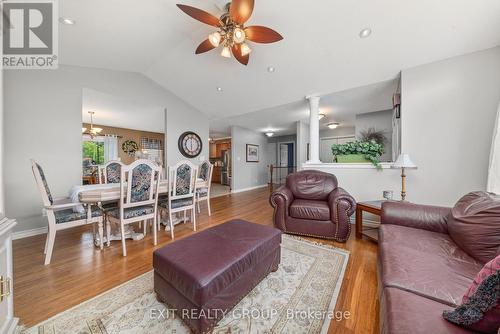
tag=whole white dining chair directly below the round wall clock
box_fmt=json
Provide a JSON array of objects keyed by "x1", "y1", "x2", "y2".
[{"x1": 158, "y1": 160, "x2": 198, "y2": 239}]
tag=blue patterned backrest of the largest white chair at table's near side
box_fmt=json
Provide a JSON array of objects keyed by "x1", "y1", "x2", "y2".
[{"x1": 120, "y1": 159, "x2": 160, "y2": 217}]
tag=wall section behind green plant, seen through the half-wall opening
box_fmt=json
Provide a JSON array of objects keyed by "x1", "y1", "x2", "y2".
[{"x1": 355, "y1": 110, "x2": 392, "y2": 161}]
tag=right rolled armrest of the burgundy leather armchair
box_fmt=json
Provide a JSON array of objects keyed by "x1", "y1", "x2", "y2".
[{"x1": 328, "y1": 187, "x2": 356, "y2": 242}]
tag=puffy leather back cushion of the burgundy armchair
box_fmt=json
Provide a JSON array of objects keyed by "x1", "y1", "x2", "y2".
[{"x1": 286, "y1": 170, "x2": 337, "y2": 201}]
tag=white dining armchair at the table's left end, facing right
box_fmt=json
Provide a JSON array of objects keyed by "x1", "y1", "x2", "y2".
[{"x1": 31, "y1": 159, "x2": 105, "y2": 265}]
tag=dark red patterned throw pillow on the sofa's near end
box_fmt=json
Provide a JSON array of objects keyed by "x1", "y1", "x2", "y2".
[{"x1": 443, "y1": 256, "x2": 500, "y2": 333}]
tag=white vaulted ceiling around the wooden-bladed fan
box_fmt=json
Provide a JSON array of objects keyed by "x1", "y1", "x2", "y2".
[{"x1": 59, "y1": 0, "x2": 500, "y2": 118}]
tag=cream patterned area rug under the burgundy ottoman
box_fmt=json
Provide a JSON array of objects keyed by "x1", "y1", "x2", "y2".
[{"x1": 23, "y1": 235, "x2": 349, "y2": 334}]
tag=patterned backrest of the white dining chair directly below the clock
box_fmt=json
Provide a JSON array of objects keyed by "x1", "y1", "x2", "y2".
[{"x1": 168, "y1": 160, "x2": 198, "y2": 200}]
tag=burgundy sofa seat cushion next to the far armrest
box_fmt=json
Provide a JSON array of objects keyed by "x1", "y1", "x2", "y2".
[{"x1": 379, "y1": 225, "x2": 482, "y2": 307}]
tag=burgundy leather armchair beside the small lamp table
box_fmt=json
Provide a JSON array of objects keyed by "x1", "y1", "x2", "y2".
[{"x1": 270, "y1": 170, "x2": 356, "y2": 242}]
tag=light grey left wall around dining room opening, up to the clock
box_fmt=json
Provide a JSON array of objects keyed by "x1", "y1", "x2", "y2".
[{"x1": 4, "y1": 66, "x2": 208, "y2": 231}]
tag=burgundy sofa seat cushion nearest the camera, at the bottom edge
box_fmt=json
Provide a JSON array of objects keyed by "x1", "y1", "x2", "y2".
[{"x1": 380, "y1": 288, "x2": 471, "y2": 334}]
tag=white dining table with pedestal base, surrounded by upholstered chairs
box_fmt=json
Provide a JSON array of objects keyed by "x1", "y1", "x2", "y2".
[{"x1": 70, "y1": 178, "x2": 207, "y2": 246}]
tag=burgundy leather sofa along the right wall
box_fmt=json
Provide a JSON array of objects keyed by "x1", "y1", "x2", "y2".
[{"x1": 378, "y1": 192, "x2": 500, "y2": 334}]
